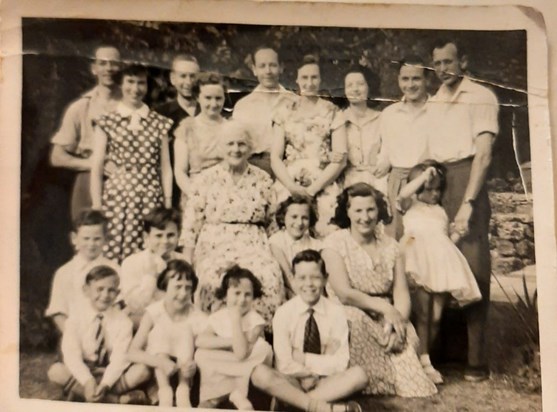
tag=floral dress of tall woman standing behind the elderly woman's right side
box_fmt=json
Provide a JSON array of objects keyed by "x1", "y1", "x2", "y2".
[{"x1": 273, "y1": 99, "x2": 344, "y2": 237}]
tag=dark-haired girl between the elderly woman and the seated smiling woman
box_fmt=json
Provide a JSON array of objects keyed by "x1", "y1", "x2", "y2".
[{"x1": 269, "y1": 195, "x2": 322, "y2": 299}]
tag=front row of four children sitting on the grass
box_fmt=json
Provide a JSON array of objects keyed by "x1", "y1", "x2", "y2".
[{"x1": 49, "y1": 245, "x2": 367, "y2": 412}]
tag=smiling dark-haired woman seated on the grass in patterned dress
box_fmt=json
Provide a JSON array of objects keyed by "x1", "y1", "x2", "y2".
[{"x1": 322, "y1": 183, "x2": 437, "y2": 397}]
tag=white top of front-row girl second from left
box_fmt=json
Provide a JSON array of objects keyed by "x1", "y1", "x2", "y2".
[{"x1": 145, "y1": 300, "x2": 208, "y2": 362}]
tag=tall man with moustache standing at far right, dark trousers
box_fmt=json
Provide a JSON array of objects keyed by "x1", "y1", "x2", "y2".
[{"x1": 428, "y1": 39, "x2": 499, "y2": 381}]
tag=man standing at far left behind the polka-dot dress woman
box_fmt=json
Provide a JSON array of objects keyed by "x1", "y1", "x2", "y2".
[{"x1": 50, "y1": 45, "x2": 120, "y2": 220}]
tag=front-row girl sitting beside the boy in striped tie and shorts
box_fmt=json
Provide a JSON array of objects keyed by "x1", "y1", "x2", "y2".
[{"x1": 128, "y1": 260, "x2": 207, "y2": 407}]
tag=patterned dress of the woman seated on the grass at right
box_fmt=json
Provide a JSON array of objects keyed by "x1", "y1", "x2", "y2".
[{"x1": 324, "y1": 229, "x2": 437, "y2": 397}]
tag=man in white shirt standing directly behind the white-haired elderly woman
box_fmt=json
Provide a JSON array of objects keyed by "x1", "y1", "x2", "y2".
[{"x1": 232, "y1": 46, "x2": 294, "y2": 176}]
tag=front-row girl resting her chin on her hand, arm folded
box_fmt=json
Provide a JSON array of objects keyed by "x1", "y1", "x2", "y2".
[{"x1": 195, "y1": 266, "x2": 273, "y2": 410}]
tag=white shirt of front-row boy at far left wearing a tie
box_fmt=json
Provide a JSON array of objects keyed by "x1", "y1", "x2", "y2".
[{"x1": 62, "y1": 303, "x2": 133, "y2": 387}]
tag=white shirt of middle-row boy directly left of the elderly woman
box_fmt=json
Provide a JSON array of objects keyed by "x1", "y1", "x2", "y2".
[{"x1": 117, "y1": 249, "x2": 187, "y2": 313}]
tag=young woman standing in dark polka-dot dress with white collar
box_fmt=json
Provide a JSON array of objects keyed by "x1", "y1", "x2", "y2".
[{"x1": 91, "y1": 64, "x2": 172, "y2": 263}]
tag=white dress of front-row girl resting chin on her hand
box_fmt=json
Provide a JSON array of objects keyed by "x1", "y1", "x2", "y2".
[{"x1": 195, "y1": 308, "x2": 273, "y2": 402}]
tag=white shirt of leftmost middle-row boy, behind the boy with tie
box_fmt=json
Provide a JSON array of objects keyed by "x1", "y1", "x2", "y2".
[{"x1": 45, "y1": 253, "x2": 120, "y2": 316}]
